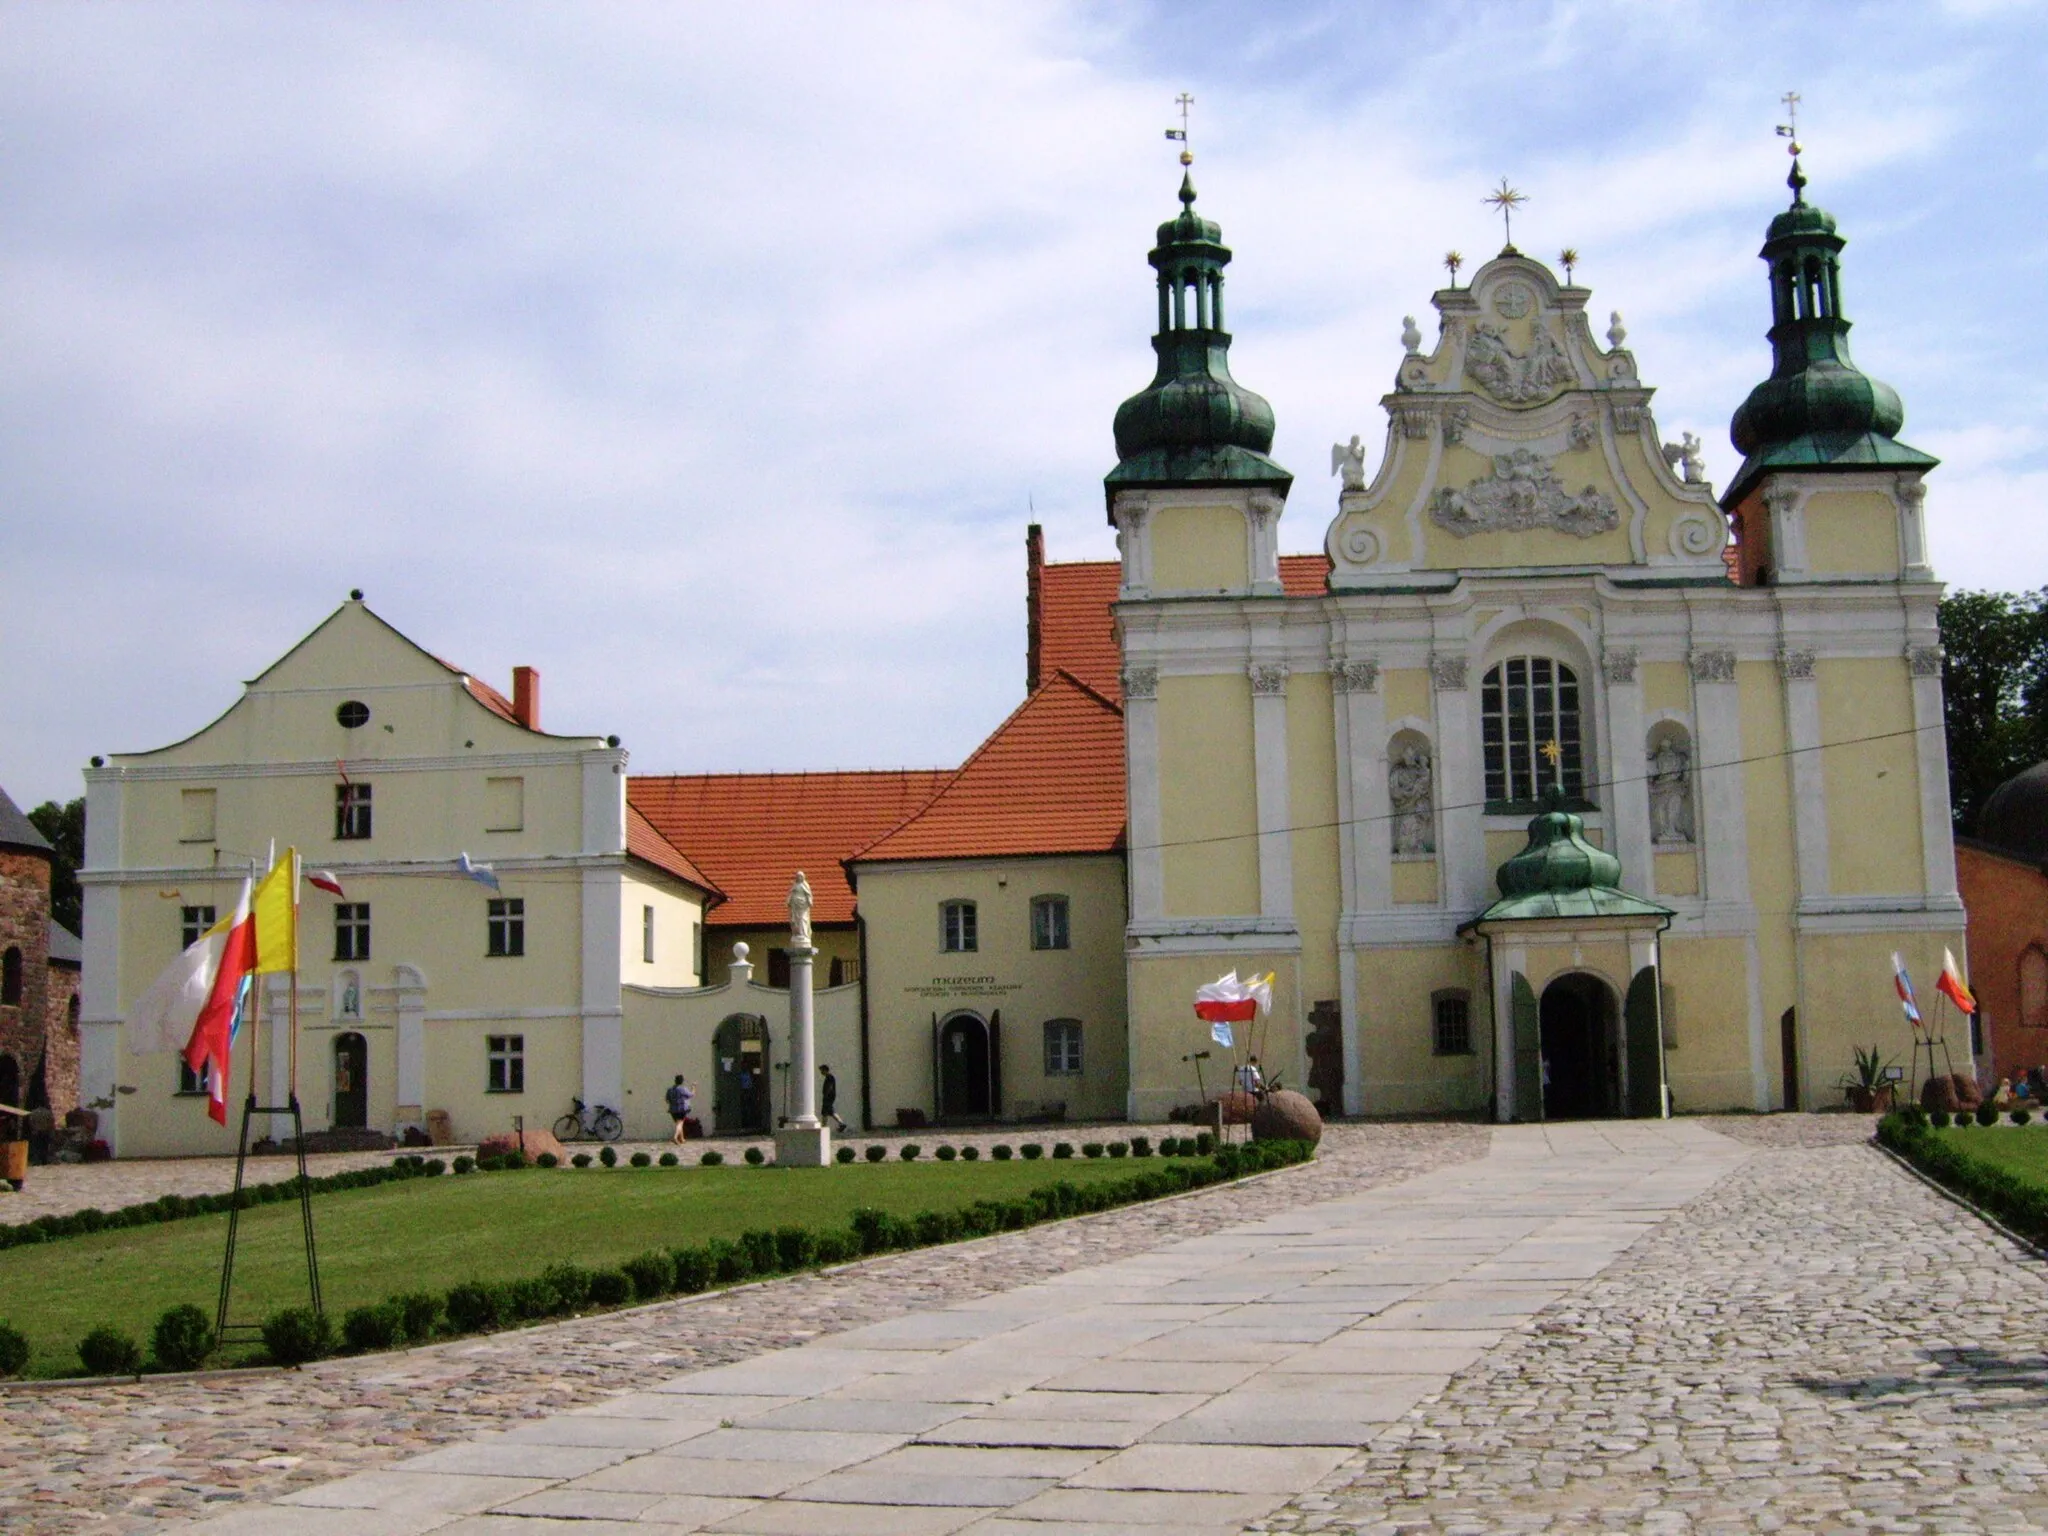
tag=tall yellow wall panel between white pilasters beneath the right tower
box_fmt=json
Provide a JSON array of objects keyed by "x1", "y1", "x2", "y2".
[{"x1": 1815, "y1": 657, "x2": 1925, "y2": 895}]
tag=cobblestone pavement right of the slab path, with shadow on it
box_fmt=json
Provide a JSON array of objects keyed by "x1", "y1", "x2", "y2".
[{"x1": 1253, "y1": 1116, "x2": 2048, "y2": 1536}]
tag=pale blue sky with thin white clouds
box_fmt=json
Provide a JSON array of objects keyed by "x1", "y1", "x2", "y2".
[{"x1": 0, "y1": 0, "x2": 2048, "y2": 805}]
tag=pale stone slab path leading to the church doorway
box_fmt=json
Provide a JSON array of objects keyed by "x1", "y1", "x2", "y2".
[{"x1": 148, "y1": 1122, "x2": 1749, "y2": 1536}]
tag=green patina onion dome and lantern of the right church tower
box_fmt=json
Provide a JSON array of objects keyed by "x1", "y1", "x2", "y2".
[{"x1": 1720, "y1": 162, "x2": 1937, "y2": 508}]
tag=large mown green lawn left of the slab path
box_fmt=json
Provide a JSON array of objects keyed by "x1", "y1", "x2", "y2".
[{"x1": 0, "y1": 1163, "x2": 1138, "y2": 1376}]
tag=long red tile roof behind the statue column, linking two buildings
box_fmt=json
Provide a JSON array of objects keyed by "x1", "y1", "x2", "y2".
[{"x1": 627, "y1": 768, "x2": 952, "y2": 928}]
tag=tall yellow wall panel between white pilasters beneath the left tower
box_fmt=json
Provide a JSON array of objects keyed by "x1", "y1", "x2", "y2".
[{"x1": 1157, "y1": 674, "x2": 1260, "y2": 918}]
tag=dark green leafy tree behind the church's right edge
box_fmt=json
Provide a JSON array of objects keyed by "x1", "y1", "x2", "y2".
[{"x1": 1942, "y1": 588, "x2": 2048, "y2": 836}]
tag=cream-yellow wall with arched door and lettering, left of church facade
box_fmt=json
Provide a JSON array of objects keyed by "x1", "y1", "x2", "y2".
[{"x1": 842, "y1": 856, "x2": 1128, "y2": 1124}]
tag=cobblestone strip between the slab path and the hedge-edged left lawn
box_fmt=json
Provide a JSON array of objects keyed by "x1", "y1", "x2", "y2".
[{"x1": 0, "y1": 1124, "x2": 1491, "y2": 1536}]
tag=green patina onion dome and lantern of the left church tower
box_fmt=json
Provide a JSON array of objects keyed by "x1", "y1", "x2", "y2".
[{"x1": 1104, "y1": 176, "x2": 1294, "y2": 512}]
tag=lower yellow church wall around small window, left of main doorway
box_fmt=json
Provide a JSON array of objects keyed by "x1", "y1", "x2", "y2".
[{"x1": 1358, "y1": 944, "x2": 1493, "y2": 1114}]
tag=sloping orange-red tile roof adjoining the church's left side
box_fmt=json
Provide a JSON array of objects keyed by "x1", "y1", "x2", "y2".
[{"x1": 848, "y1": 672, "x2": 1124, "y2": 864}]
